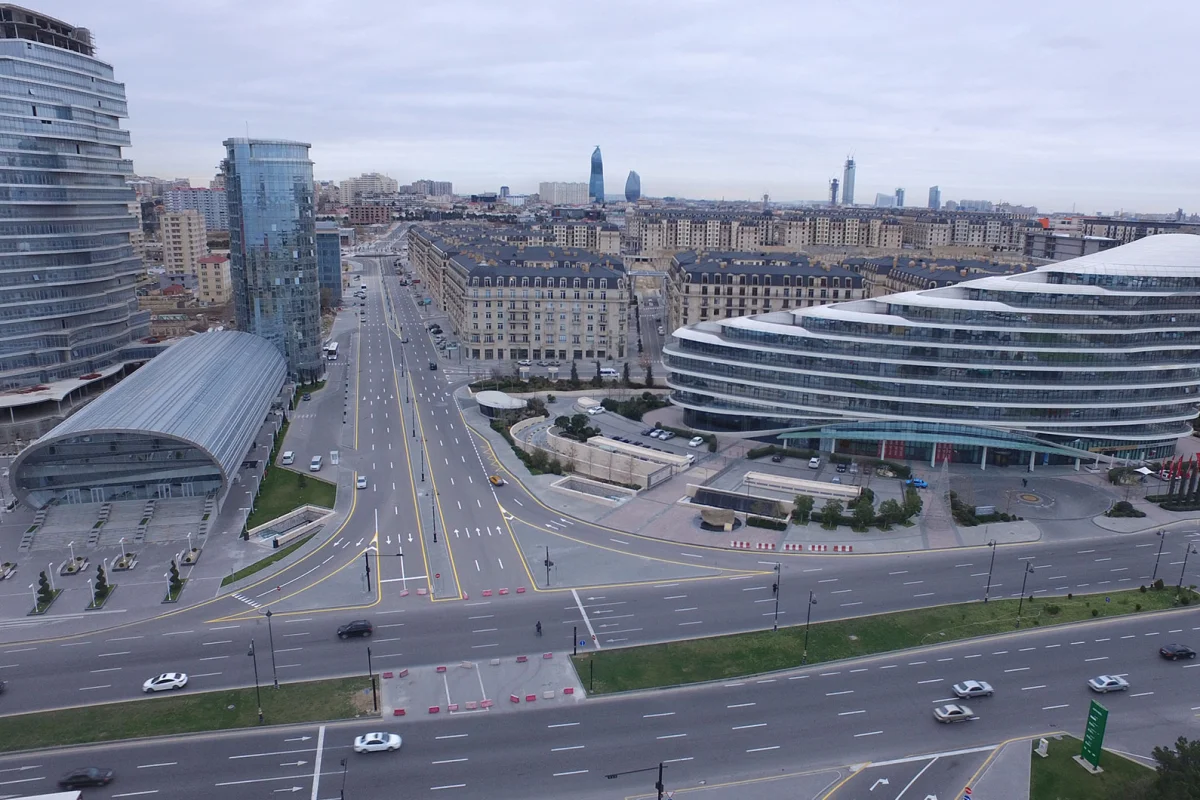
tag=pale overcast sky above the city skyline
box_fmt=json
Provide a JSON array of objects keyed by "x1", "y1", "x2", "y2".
[{"x1": 39, "y1": 0, "x2": 1200, "y2": 212}]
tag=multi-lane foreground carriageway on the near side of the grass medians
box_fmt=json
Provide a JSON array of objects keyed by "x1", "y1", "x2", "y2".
[{"x1": 0, "y1": 610, "x2": 1200, "y2": 800}]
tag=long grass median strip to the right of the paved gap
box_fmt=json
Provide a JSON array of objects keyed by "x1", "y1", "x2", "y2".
[{"x1": 575, "y1": 587, "x2": 1198, "y2": 693}]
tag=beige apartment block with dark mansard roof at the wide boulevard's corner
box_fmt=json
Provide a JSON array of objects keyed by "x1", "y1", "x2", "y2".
[{"x1": 408, "y1": 225, "x2": 630, "y2": 362}]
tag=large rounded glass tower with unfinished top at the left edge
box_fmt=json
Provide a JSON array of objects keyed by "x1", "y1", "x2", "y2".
[{"x1": 0, "y1": 5, "x2": 150, "y2": 393}]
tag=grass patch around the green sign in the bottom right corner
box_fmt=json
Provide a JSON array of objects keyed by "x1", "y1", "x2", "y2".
[{"x1": 1030, "y1": 736, "x2": 1154, "y2": 800}]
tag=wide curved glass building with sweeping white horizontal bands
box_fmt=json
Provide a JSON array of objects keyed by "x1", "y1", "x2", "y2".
[{"x1": 664, "y1": 234, "x2": 1200, "y2": 467}]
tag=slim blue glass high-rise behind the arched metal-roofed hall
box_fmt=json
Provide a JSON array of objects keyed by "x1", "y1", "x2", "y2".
[{"x1": 221, "y1": 138, "x2": 325, "y2": 380}]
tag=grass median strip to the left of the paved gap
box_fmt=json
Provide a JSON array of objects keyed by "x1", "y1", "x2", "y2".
[{"x1": 0, "y1": 676, "x2": 371, "y2": 752}]
